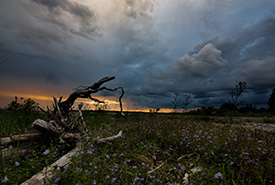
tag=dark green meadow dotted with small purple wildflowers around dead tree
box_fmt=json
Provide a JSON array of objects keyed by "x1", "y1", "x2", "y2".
[{"x1": 0, "y1": 110, "x2": 275, "y2": 184}]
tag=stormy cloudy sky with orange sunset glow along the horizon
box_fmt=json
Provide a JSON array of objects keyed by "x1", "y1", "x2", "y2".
[{"x1": 0, "y1": 0, "x2": 275, "y2": 110}]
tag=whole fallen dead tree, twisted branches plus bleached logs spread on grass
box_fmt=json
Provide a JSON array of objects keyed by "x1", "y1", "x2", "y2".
[{"x1": 0, "y1": 77, "x2": 124, "y2": 184}]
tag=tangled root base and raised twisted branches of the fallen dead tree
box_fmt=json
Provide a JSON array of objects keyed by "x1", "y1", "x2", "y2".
[{"x1": 33, "y1": 76, "x2": 124, "y2": 143}]
